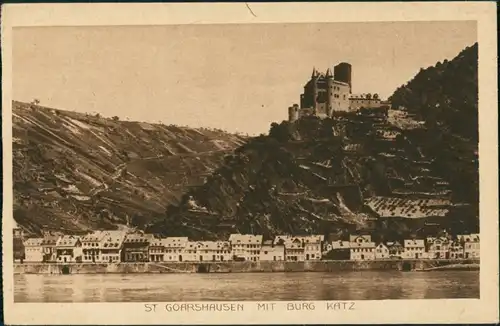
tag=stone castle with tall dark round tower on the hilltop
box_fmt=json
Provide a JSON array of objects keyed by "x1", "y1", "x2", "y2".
[{"x1": 288, "y1": 62, "x2": 390, "y2": 122}]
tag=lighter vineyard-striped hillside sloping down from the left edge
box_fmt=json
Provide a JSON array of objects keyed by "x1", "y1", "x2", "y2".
[{"x1": 12, "y1": 102, "x2": 246, "y2": 233}]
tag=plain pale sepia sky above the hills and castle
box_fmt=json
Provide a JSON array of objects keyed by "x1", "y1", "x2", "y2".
[{"x1": 12, "y1": 21, "x2": 477, "y2": 135}]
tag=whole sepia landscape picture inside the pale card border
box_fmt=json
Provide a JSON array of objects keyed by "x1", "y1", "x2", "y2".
[{"x1": 2, "y1": 3, "x2": 498, "y2": 321}]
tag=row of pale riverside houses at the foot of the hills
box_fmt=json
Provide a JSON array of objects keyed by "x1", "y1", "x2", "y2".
[{"x1": 18, "y1": 231, "x2": 479, "y2": 263}]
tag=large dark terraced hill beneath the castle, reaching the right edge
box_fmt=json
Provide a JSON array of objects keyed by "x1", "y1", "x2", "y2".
[{"x1": 150, "y1": 46, "x2": 478, "y2": 239}]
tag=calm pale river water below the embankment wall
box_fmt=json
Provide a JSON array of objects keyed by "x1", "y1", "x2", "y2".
[{"x1": 14, "y1": 271, "x2": 479, "y2": 302}]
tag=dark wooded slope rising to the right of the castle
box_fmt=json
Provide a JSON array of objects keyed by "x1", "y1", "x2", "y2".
[{"x1": 390, "y1": 43, "x2": 479, "y2": 205}]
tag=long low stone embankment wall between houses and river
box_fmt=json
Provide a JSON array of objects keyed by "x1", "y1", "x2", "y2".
[{"x1": 14, "y1": 259, "x2": 479, "y2": 274}]
